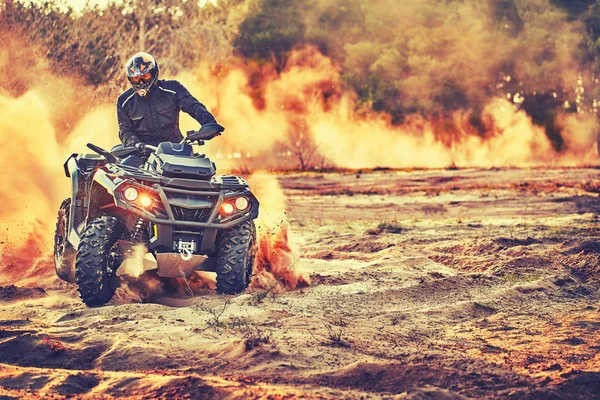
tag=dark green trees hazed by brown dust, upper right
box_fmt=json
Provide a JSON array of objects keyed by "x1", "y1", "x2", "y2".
[{"x1": 236, "y1": 0, "x2": 600, "y2": 135}]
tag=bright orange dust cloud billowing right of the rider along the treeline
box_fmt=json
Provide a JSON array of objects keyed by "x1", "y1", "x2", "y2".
[{"x1": 179, "y1": 48, "x2": 599, "y2": 169}]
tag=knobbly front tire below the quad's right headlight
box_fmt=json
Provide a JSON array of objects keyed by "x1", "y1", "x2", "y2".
[{"x1": 217, "y1": 221, "x2": 256, "y2": 294}]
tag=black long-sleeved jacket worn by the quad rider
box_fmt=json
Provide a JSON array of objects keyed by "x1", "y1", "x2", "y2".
[{"x1": 117, "y1": 80, "x2": 216, "y2": 146}]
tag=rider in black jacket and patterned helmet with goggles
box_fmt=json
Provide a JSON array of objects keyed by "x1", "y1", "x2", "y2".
[{"x1": 117, "y1": 52, "x2": 216, "y2": 150}]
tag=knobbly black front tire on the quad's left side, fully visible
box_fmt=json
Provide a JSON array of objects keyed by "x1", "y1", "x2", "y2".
[{"x1": 75, "y1": 216, "x2": 125, "y2": 307}]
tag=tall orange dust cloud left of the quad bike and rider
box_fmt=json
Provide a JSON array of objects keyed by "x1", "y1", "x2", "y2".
[{"x1": 0, "y1": 36, "x2": 117, "y2": 285}]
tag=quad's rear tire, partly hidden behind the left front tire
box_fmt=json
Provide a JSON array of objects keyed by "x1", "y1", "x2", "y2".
[{"x1": 54, "y1": 199, "x2": 77, "y2": 283}]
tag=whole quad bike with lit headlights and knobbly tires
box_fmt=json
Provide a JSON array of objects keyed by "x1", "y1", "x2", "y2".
[{"x1": 54, "y1": 124, "x2": 259, "y2": 307}]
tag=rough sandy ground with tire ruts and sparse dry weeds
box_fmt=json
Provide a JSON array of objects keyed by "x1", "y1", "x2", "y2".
[{"x1": 0, "y1": 169, "x2": 600, "y2": 399}]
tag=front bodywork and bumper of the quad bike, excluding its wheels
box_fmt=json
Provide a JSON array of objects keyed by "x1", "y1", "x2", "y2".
[{"x1": 58, "y1": 143, "x2": 259, "y2": 284}]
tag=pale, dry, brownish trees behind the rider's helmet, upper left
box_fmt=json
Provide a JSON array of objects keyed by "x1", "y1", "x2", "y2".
[{"x1": 0, "y1": 0, "x2": 246, "y2": 85}]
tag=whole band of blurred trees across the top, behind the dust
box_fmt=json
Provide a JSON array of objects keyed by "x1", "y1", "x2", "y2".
[{"x1": 0, "y1": 0, "x2": 600, "y2": 149}]
